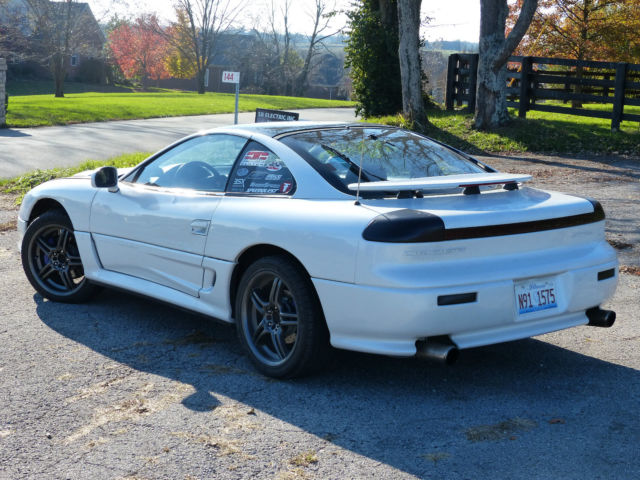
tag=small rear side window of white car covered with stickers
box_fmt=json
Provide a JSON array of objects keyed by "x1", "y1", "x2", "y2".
[{"x1": 227, "y1": 141, "x2": 296, "y2": 195}]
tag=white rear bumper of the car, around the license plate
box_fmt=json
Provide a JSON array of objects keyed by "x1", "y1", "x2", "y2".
[{"x1": 313, "y1": 256, "x2": 618, "y2": 356}]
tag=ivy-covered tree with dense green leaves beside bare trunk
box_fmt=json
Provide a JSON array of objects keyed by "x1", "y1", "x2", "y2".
[{"x1": 345, "y1": 0, "x2": 402, "y2": 118}]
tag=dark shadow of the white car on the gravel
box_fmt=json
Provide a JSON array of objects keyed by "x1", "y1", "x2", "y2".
[{"x1": 34, "y1": 290, "x2": 640, "y2": 478}]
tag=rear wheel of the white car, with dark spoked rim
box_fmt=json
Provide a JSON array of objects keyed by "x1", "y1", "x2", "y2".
[{"x1": 235, "y1": 255, "x2": 330, "y2": 378}]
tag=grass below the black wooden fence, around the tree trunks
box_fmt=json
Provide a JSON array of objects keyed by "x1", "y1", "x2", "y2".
[{"x1": 368, "y1": 105, "x2": 640, "y2": 156}]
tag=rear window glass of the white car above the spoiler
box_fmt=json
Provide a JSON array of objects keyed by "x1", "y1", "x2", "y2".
[{"x1": 281, "y1": 127, "x2": 485, "y2": 194}]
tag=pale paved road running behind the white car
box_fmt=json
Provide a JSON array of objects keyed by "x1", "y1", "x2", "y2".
[{"x1": 0, "y1": 108, "x2": 355, "y2": 178}]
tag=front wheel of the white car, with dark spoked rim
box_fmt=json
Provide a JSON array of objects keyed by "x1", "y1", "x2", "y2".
[{"x1": 22, "y1": 210, "x2": 98, "y2": 303}]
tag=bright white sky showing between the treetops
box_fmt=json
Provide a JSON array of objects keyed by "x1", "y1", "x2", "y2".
[{"x1": 88, "y1": 0, "x2": 480, "y2": 42}]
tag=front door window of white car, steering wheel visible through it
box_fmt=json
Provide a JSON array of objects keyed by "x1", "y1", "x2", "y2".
[{"x1": 133, "y1": 134, "x2": 247, "y2": 192}]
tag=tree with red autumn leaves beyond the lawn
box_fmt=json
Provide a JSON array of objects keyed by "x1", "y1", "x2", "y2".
[{"x1": 109, "y1": 15, "x2": 169, "y2": 89}]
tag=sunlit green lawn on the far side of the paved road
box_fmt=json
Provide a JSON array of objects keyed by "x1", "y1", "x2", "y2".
[{"x1": 7, "y1": 90, "x2": 353, "y2": 127}]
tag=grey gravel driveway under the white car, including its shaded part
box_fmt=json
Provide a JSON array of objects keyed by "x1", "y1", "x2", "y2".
[{"x1": 0, "y1": 156, "x2": 640, "y2": 480}]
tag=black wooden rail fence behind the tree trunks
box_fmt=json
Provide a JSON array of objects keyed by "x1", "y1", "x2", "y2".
[{"x1": 446, "y1": 53, "x2": 640, "y2": 130}]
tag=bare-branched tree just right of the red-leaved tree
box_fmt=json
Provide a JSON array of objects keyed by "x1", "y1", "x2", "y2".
[{"x1": 165, "y1": 0, "x2": 245, "y2": 93}]
